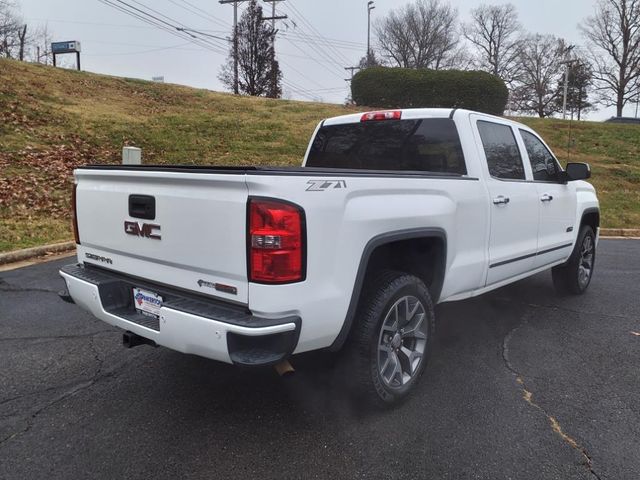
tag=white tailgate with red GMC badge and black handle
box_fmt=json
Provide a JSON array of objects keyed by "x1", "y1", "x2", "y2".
[{"x1": 75, "y1": 169, "x2": 248, "y2": 303}]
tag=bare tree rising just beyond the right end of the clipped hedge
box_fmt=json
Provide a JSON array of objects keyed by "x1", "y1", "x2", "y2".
[{"x1": 462, "y1": 3, "x2": 522, "y2": 84}]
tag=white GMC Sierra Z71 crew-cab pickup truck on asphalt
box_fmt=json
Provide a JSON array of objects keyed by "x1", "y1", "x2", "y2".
[{"x1": 60, "y1": 109, "x2": 600, "y2": 404}]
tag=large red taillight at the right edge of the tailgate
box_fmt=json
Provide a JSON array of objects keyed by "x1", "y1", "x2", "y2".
[{"x1": 247, "y1": 198, "x2": 305, "y2": 283}]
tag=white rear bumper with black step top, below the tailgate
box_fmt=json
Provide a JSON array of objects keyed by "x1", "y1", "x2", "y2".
[{"x1": 60, "y1": 265, "x2": 301, "y2": 366}]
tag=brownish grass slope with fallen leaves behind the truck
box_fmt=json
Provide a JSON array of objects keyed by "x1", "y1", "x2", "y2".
[{"x1": 0, "y1": 59, "x2": 640, "y2": 251}]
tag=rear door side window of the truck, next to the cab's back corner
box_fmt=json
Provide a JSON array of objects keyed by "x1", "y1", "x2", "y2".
[{"x1": 478, "y1": 120, "x2": 525, "y2": 180}]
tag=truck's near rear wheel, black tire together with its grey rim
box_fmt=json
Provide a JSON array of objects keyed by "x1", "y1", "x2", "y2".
[{"x1": 347, "y1": 271, "x2": 435, "y2": 406}]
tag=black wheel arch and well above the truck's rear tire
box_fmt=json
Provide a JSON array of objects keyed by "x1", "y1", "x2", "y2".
[{"x1": 329, "y1": 228, "x2": 447, "y2": 351}]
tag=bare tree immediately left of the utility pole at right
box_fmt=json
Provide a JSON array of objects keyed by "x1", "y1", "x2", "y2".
[{"x1": 512, "y1": 35, "x2": 567, "y2": 118}]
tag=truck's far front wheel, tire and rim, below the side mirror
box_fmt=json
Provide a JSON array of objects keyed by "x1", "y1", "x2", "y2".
[{"x1": 551, "y1": 225, "x2": 596, "y2": 295}]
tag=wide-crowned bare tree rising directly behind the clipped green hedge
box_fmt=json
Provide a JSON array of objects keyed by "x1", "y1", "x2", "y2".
[{"x1": 374, "y1": 0, "x2": 459, "y2": 70}]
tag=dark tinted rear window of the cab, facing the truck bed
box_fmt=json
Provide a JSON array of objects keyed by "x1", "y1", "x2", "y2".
[{"x1": 306, "y1": 118, "x2": 467, "y2": 175}]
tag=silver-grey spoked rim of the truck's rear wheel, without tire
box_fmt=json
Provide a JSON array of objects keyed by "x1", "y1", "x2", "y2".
[{"x1": 378, "y1": 295, "x2": 429, "y2": 389}]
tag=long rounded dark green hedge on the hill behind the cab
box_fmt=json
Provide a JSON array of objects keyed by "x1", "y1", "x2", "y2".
[{"x1": 351, "y1": 67, "x2": 509, "y2": 115}]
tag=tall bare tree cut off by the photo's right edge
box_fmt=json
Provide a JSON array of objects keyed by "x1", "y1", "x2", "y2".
[{"x1": 581, "y1": 0, "x2": 640, "y2": 117}]
